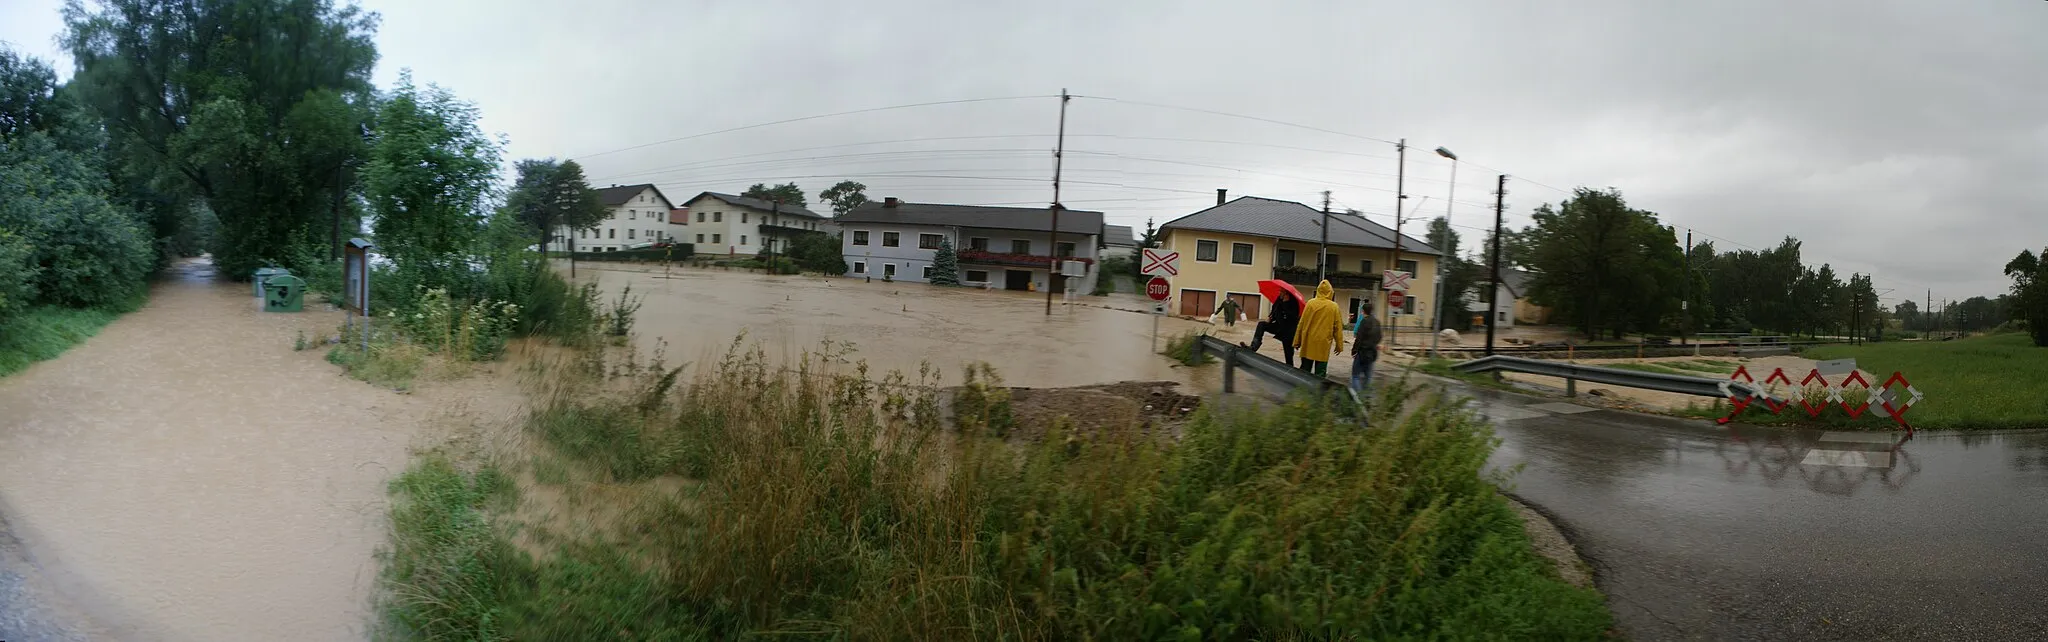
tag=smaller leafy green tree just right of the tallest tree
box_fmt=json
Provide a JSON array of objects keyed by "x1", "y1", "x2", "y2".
[{"x1": 362, "y1": 72, "x2": 500, "y2": 267}]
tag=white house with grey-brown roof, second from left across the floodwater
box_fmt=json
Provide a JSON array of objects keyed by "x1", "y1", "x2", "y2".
[{"x1": 676, "y1": 191, "x2": 838, "y2": 256}]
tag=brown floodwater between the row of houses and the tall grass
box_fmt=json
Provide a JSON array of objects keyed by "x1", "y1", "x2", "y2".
[{"x1": 578, "y1": 263, "x2": 1217, "y2": 390}]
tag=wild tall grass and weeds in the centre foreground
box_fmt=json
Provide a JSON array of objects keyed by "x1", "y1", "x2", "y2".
[{"x1": 387, "y1": 343, "x2": 1610, "y2": 640}]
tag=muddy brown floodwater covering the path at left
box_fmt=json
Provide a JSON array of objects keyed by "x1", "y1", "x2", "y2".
[{"x1": 0, "y1": 256, "x2": 449, "y2": 640}]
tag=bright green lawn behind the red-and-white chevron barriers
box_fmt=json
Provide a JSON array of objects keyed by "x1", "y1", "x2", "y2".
[{"x1": 1802, "y1": 332, "x2": 2048, "y2": 431}]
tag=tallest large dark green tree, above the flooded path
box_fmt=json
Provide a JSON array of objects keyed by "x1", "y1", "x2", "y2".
[{"x1": 63, "y1": 0, "x2": 377, "y2": 279}]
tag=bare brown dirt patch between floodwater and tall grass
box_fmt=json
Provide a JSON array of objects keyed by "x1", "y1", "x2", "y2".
[{"x1": 1010, "y1": 382, "x2": 1202, "y2": 439}]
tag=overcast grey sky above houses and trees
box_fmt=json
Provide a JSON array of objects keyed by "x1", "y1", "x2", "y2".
[{"x1": 0, "y1": 0, "x2": 2048, "y2": 304}]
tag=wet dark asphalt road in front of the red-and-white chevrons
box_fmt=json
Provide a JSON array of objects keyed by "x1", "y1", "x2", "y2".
[{"x1": 1456, "y1": 386, "x2": 2048, "y2": 640}]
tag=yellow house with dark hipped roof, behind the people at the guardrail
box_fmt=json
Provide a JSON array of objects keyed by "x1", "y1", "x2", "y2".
[{"x1": 1159, "y1": 197, "x2": 1440, "y2": 330}]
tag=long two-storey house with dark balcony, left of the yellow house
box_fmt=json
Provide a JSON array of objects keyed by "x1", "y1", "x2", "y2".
[{"x1": 838, "y1": 197, "x2": 1104, "y2": 293}]
